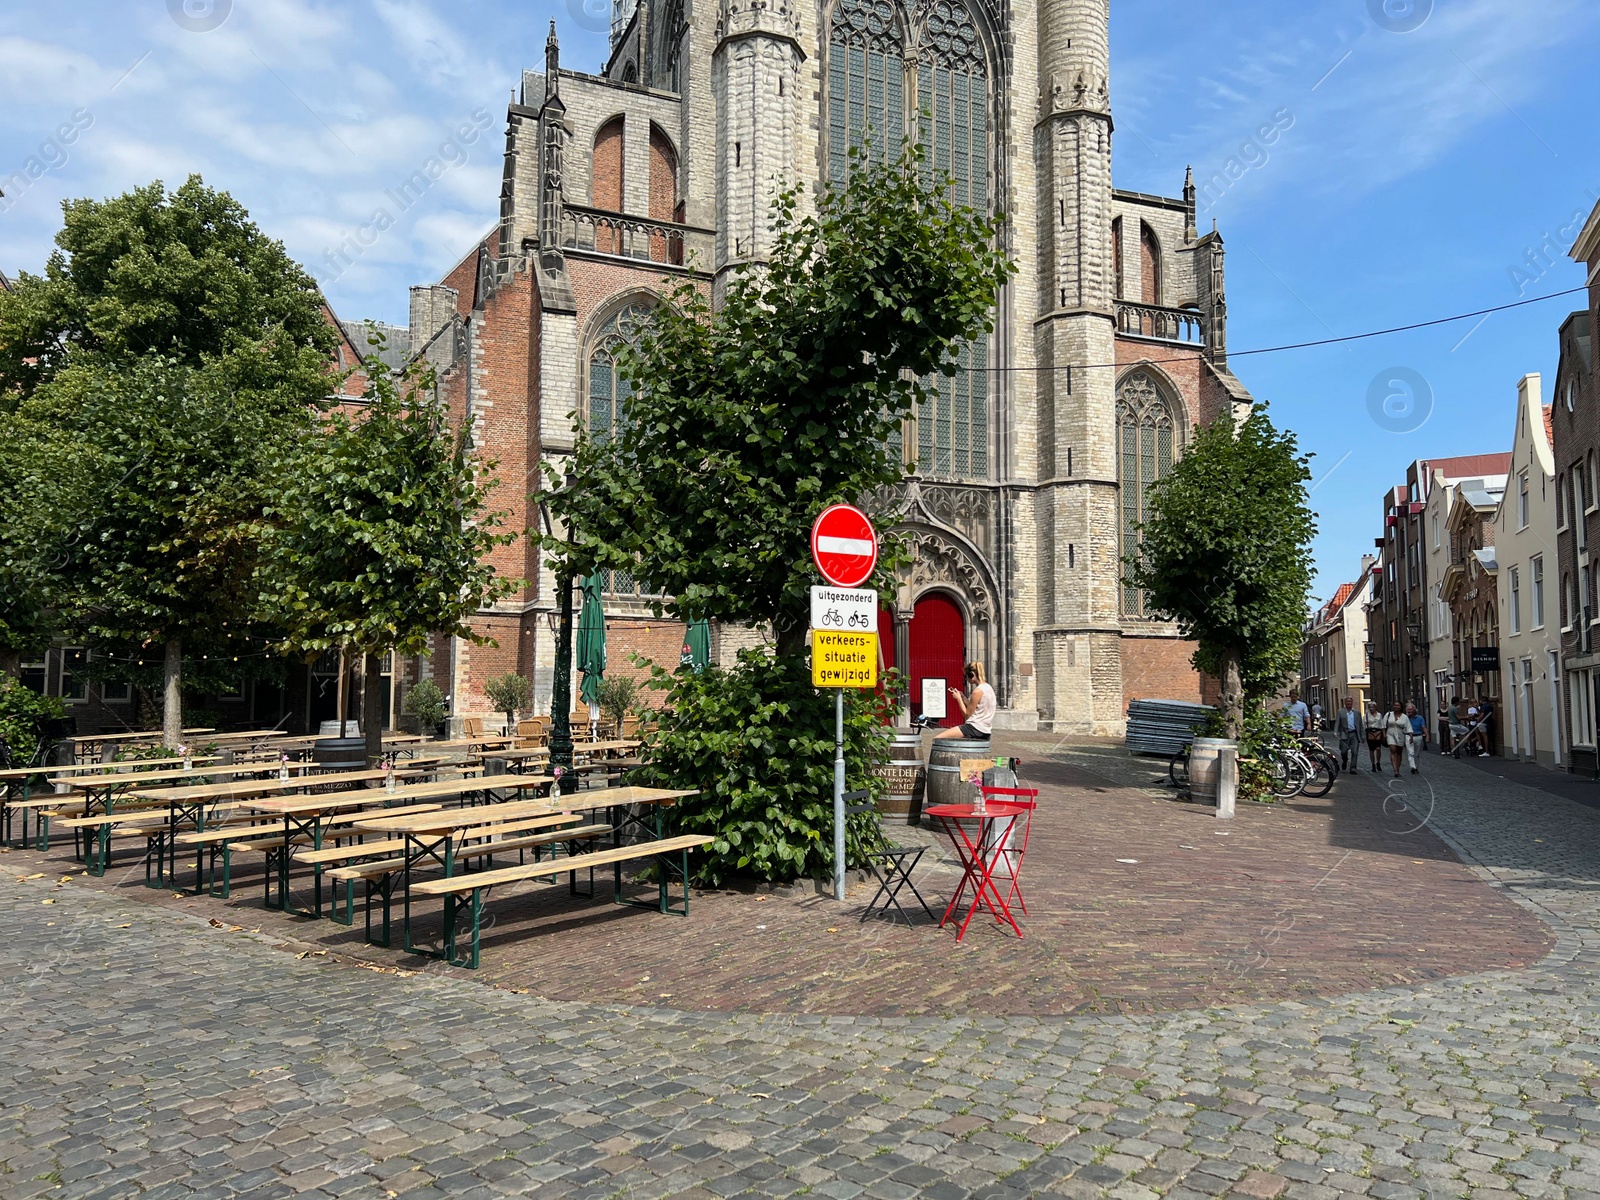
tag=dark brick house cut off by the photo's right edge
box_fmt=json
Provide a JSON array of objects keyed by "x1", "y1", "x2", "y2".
[{"x1": 1550, "y1": 205, "x2": 1600, "y2": 774}]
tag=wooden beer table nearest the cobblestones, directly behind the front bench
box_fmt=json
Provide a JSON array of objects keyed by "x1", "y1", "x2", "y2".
[{"x1": 355, "y1": 790, "x2": 696, "y2": 966}]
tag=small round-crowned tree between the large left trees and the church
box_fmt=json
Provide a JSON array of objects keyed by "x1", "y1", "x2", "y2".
[{"x1": 256, "y1": 360, "x2": 522, "y2": 762}]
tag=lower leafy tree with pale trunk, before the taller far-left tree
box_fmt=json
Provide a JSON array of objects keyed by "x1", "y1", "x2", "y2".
[{"x1": 21, "y1": 355, "x2": 312, "y2": 746}]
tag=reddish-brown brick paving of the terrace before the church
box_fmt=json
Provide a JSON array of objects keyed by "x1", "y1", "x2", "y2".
[{"x1": 0, "y1": 739, "x2": 1554, "y2": 1016}]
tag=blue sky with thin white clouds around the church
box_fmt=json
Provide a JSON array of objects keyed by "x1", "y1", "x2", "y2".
[{"x1": 0, "y1": 0, "x2": 1600, "y2": 597}]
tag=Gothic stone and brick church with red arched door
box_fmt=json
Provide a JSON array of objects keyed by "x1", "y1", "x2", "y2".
[{"x1": 410, "y1": 0, "x2": 1250, "y2": 734}]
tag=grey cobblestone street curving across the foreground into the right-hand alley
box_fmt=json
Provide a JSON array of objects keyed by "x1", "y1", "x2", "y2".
[{"x1": 0, "y1": 748, "x2": 1600, "y2": 1200}]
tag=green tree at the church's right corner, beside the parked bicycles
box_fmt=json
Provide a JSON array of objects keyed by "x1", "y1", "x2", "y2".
[{"x1": 1125, "y1": 403, "x2": 1317, "y2": 738}]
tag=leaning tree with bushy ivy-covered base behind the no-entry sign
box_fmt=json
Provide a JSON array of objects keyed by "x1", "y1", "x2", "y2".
[{"x1": 544, "y1": 147, "x2": 1013, "y2": 880}]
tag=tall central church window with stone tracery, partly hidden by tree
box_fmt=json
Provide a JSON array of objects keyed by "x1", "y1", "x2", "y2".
[{"x1": 827, "y1": 0, "x2": 990, "y2": 480}]
